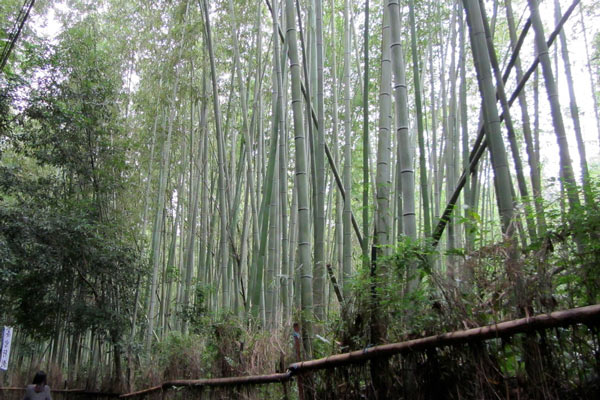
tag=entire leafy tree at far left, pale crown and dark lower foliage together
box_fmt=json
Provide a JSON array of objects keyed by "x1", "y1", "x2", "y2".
[{"x1": 0, "y1": 17, "x2": 143, "y2": 344}]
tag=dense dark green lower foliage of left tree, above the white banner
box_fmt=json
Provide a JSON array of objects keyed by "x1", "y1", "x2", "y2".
[{"x1": 0, "y1": 204, "x2": 139, "y2": 339}]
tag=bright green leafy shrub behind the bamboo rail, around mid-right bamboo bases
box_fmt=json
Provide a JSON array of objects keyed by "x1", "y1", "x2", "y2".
[{"x1": 330, "y1": 237, "x2": 439, "y2": 351}]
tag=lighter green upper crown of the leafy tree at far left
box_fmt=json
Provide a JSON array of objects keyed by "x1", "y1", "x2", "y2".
[{"x1": 15, "y1": 18, "x2": 127, "y2": 215}]
